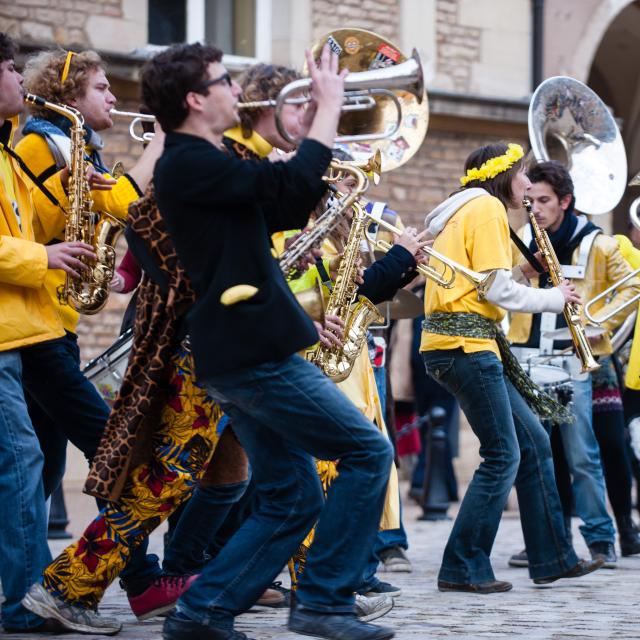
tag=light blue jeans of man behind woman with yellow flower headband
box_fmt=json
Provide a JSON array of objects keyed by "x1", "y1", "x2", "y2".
[{"x1": 560, "y1": 376, "x2": 615, "y2": 545}]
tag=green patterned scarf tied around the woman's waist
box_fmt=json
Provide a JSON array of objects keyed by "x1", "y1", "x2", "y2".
[{"x1": 422, "y1": 312, "x2": 575, "y2": 424}]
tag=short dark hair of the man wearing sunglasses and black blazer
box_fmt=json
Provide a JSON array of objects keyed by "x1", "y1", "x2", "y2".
[{"x1": 142, "y1": 43, "x2": 222, "y2": 131}]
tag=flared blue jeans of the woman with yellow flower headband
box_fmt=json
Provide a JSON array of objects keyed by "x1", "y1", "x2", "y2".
[{"x1": 423, "y1": 349, "x2": 578, "y2": 584}]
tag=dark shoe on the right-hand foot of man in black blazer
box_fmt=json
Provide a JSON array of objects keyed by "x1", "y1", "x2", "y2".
[{"x1": 288, "y1": 609, "x2": 394, "y2": 640}]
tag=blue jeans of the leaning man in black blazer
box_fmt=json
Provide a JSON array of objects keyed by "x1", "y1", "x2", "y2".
[{"x1": 178, "y1": 355, "x2": 393, "y2": 629}]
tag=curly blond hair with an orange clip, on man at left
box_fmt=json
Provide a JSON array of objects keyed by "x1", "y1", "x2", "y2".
[{"x1": 23, "y1": 49, "x2": 105, "y2": 118}]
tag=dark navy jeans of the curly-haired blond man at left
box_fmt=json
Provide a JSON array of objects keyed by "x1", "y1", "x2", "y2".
[{"x1": 21, "y1": 332, "x2": 161, "y2": 592}]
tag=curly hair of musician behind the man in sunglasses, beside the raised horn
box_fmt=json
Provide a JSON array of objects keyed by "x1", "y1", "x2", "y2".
[{"x1": 240, "y1": 63, "x2": 300, "y2": 138}]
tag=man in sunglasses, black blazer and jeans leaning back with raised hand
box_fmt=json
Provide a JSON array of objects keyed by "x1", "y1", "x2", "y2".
[{"x1": 143, "y1": 45, "x2": 400, "y2": 640}]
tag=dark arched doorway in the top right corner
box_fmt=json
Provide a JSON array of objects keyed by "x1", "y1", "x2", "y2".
[{"x1": 587, "y1": 0, "x2": 640, "y2": 233}]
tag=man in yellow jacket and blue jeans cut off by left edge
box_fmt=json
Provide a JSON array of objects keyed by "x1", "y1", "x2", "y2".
[{"x1": 0, "y1": 33, "x2": 95, "y2": 633}]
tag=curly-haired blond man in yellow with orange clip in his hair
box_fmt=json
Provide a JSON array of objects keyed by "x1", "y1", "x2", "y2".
[{"x1": 16, "y1": 50, "x2": 175, "y2": 608}]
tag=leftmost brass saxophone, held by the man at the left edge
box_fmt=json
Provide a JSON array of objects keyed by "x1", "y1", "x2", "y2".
[{"x1": 24, "y1": 93, "x2": 124, "y2": 315}]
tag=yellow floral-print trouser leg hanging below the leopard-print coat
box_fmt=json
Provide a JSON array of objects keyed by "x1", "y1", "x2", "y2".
[{"x1": 43, "y1": 347, "x2": 222, "y2": 608}]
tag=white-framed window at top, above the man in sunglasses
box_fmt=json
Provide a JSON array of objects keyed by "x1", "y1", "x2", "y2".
[{"x1": 149, "y1": 0, "x2": 271, "y2": 60}]
